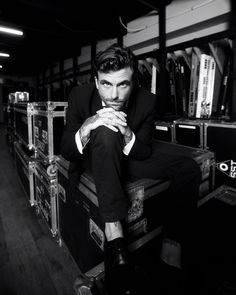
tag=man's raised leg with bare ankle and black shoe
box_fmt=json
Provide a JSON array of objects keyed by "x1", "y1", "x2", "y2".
[{"x1": 89, "y1": 127, "x2": 132, "y2": 295}]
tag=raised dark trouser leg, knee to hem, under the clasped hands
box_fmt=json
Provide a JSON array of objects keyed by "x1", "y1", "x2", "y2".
[{"x1": 89, "y1": 127, "x2": 127, "y2": 223}]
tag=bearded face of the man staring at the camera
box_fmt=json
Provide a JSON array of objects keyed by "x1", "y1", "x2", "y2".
[{"x1": 95, "y1": 67, "x2": 133, "y2": 111}]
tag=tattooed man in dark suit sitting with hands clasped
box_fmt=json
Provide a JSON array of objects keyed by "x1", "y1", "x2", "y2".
[{"x1": 61, "y1": 44, "x2": 200, "y2": 294}]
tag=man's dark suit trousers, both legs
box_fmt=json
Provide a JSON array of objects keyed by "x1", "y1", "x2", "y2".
[{"x1": 88, "y1": 127, "x2": 201, "y2": 247}]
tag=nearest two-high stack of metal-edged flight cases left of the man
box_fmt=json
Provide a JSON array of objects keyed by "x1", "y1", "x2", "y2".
[{"x1": 33, "y1": 101, "x2": 68, "y2": 236}]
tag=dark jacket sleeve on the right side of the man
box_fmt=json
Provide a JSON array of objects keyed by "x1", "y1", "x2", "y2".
[{"x1": 128, "y1": 95, "x2": 156, "y2": 160}]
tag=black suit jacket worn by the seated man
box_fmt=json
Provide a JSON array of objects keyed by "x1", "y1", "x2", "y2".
[{"x1": 61, "y1": 83, "x2": 156, "y2": 180}]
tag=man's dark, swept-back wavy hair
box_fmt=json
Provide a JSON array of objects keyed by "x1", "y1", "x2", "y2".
[{"x1": 93, "y1": 44, "x2": 138, "y2": 78}]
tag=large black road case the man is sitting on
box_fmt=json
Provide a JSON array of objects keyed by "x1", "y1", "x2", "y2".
[{"x1": 56, "y1": 141, "x2": 214, "y2": 290}]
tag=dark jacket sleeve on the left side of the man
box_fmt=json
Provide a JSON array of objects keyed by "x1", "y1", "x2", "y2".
[{"x1": 60, "y1": 87, "x2": 83, "y2": 161}]
